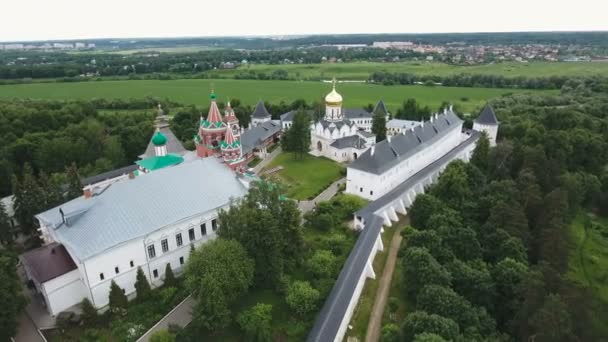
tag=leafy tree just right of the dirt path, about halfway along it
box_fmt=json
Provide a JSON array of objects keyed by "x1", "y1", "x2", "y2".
[{"x1": 403, "y1": 247, "x2": 451, "y2": 299}]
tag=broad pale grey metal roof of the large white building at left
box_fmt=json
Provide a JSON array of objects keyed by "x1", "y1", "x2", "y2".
[{"x1": 36, "y1": 158, "x2": 246, "y2": 260}]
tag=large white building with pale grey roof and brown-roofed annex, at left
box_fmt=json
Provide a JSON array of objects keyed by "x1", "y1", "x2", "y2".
[{"x1": 21, "y1": 158, "x2": 247, "y2": 315}]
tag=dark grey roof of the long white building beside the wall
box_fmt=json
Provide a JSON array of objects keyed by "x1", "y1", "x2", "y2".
[{"x1": 349, "y1": 112, "x2": 462, "y2": 174}]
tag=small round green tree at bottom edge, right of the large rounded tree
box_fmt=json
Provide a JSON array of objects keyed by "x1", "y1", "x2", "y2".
[{"x1": 236, "y1": 303, "x2": 272, "y2": 342}]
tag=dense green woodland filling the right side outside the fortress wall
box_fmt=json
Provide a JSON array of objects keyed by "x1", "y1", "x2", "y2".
[{"x1": 383, "y1": 76, "x2": 608, "y2": 341}]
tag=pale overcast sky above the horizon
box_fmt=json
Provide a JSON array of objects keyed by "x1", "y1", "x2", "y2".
[{"x1": 0, "y1": 0, "x2": 608, "y2": 41}]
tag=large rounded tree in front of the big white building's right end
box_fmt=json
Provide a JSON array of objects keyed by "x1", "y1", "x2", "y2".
[{"x1": 185, "y1": 238, "x2": 254, "y2": 331}]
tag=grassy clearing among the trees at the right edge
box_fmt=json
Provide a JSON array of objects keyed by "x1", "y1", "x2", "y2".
[{"x1": 567, "y1": 212, "x2": 608, "y2": 336}]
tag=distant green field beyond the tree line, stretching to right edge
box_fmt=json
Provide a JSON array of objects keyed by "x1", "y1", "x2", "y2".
[{"x1": 213, "y1": 61, "x2": 608, "y2": 80}]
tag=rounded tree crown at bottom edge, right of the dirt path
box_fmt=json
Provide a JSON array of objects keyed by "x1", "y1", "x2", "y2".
[{"x1": 401, "y1": 311, "x2": 459, "y2": 342}]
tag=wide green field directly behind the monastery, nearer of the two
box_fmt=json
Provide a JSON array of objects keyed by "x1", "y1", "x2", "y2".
[{"x1": 0, "y1": 78, "x2": 556, "y2": 112}]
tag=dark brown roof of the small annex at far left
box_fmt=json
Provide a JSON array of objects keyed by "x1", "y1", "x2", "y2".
[{"x1": 20, "y1": 242, "x2": 76, "y2": 283}]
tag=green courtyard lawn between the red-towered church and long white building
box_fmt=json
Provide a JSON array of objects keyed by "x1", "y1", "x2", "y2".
[{"x1": 266, "y1": 152, "x2": 343, "y2": 200}]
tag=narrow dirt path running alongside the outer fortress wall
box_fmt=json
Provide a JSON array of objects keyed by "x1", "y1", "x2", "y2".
[{"x1": 365, "y1": 224, "x2": 403, "y2": 342}]
